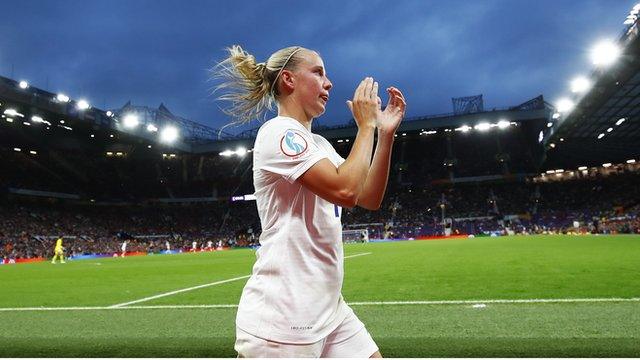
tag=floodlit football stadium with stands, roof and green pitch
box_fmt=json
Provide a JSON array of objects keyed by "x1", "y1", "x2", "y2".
[{"x1": 0, "y1": 4, "x2": 640, "y2": 357}]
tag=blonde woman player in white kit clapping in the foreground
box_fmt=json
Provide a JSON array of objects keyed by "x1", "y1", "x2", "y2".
[{"x1": 215, "y1": 46, "x2": 406, "y2": 357}]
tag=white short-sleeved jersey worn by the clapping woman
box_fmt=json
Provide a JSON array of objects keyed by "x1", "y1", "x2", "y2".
[{"x1": 236, "y1": 116, "x2": 350, "y2": 344}]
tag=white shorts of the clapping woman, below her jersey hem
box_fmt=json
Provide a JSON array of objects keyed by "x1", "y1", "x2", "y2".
[{"x1": 234, "y1": 311, "x2": 378, "y2": 358}]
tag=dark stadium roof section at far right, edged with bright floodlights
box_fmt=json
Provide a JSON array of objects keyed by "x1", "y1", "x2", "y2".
[{"x1": 544, "y1": 23, "x2": 640, "y2": 168}]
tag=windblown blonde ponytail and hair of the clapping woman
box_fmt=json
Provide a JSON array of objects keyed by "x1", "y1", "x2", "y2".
[{"x1": 212, "y1": 45, "x2": 308, "y2": 127}]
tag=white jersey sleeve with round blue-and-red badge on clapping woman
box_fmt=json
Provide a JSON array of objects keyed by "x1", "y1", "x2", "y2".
[{"x1": 254, "y1": 121, "x2": 328, "y2": 183}]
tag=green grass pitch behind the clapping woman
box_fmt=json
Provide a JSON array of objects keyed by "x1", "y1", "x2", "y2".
[{"x1": 0, "y1": 235, "x2": 640, "y2": 357}]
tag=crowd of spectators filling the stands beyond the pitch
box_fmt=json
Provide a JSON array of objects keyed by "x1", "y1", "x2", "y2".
[{"x1": 0, "y1": 169, "x2": 640, "y2": 258}]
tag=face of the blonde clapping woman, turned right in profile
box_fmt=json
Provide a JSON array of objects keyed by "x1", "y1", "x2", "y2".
[{"x1": 293, "y1": 50, "x2": 333, "y2": 119}]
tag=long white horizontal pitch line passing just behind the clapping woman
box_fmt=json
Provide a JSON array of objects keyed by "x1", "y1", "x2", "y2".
[{"x1": 0, "y1": 298, "x2": 640, "y2": 312}]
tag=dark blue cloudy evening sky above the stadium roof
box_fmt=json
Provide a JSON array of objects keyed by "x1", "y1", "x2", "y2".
[{"x1": 0, "y1": 0, "x2": 635, "y2": 132}]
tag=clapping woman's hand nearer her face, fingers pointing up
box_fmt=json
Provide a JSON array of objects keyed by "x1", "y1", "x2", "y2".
[{"x1": 347, "y1": 77, "x2": 382, "y2": 129}]
